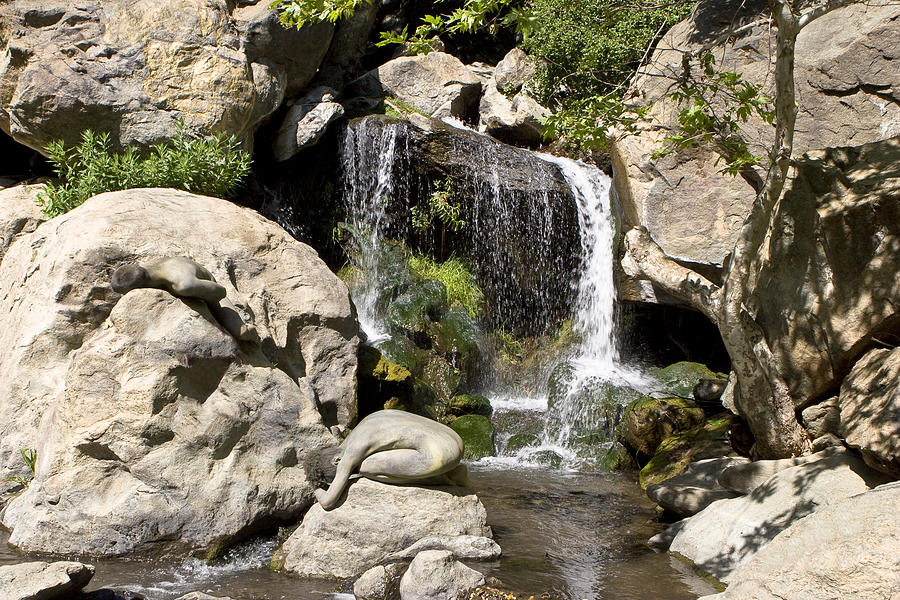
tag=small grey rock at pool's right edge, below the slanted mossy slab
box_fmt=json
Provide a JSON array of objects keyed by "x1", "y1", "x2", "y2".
[{"x1": 647, "y1": 456, "x2": 747, "y2": 518}]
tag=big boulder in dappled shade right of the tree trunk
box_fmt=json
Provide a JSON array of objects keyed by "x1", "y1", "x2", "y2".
[{"x1": 749, "y1": 138, "x2": 900, "y2": 406}]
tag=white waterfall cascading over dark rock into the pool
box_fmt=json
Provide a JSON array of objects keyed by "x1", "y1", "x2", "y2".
[{"x1": 339, "y1": 113, "x2": 644, "y2": 464}]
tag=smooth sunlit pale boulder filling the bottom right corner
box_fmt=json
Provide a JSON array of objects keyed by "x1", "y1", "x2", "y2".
[{"x1": 702, "y1": 483, "x2": 900, "y2": 600}]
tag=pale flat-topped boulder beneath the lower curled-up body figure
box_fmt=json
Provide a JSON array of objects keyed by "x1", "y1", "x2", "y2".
[{"x1": 273, "y1": 478, "x2": 491, "y2": 579}]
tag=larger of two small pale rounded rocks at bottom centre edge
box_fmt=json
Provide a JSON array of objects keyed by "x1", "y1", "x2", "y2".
[{"x1": 400, "y1": 550, "x2": 485, "y2": 600}]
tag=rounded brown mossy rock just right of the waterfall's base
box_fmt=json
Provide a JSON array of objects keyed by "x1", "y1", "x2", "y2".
[{"x1": 616, "y1": 396, "x2": 705, "y2": 460}]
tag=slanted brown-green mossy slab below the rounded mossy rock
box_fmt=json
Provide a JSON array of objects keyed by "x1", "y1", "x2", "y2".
[{"x1": 640, "y1": 414, "x2": 735, "y2": 488}]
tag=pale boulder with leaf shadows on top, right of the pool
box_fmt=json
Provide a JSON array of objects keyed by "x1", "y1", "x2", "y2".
[{"x1": 669, "y1": 451, "x2": 884, "y2": 582}]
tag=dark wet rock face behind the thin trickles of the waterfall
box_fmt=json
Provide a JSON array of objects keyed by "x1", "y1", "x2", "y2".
[{"x1": 338, "y1": 116, "x2": 581, "y2": 336}]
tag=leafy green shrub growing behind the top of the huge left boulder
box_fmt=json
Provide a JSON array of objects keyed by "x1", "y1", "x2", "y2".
[{"x1": 38, "y1": 130, "x2": 251, "y2": 217}]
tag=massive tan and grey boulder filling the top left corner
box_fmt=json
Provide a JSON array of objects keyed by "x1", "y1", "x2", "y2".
[{"x1": 0, "y1": 0, "x2": 333, "y2": 152}]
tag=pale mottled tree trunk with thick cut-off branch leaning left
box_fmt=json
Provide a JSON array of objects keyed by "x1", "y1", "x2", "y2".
[{"x1": 622, "y1": 0, "x2": 853, "y2": 458}]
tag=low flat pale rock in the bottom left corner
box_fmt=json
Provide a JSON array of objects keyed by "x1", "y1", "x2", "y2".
[{"x1": 0, "y1": 561, "x2": 94, "y2": 600}]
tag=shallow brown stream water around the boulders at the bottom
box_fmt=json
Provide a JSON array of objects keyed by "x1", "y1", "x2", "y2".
[{"x1": 0, "y1": 464, "x2": 714, "y2": 600}]
